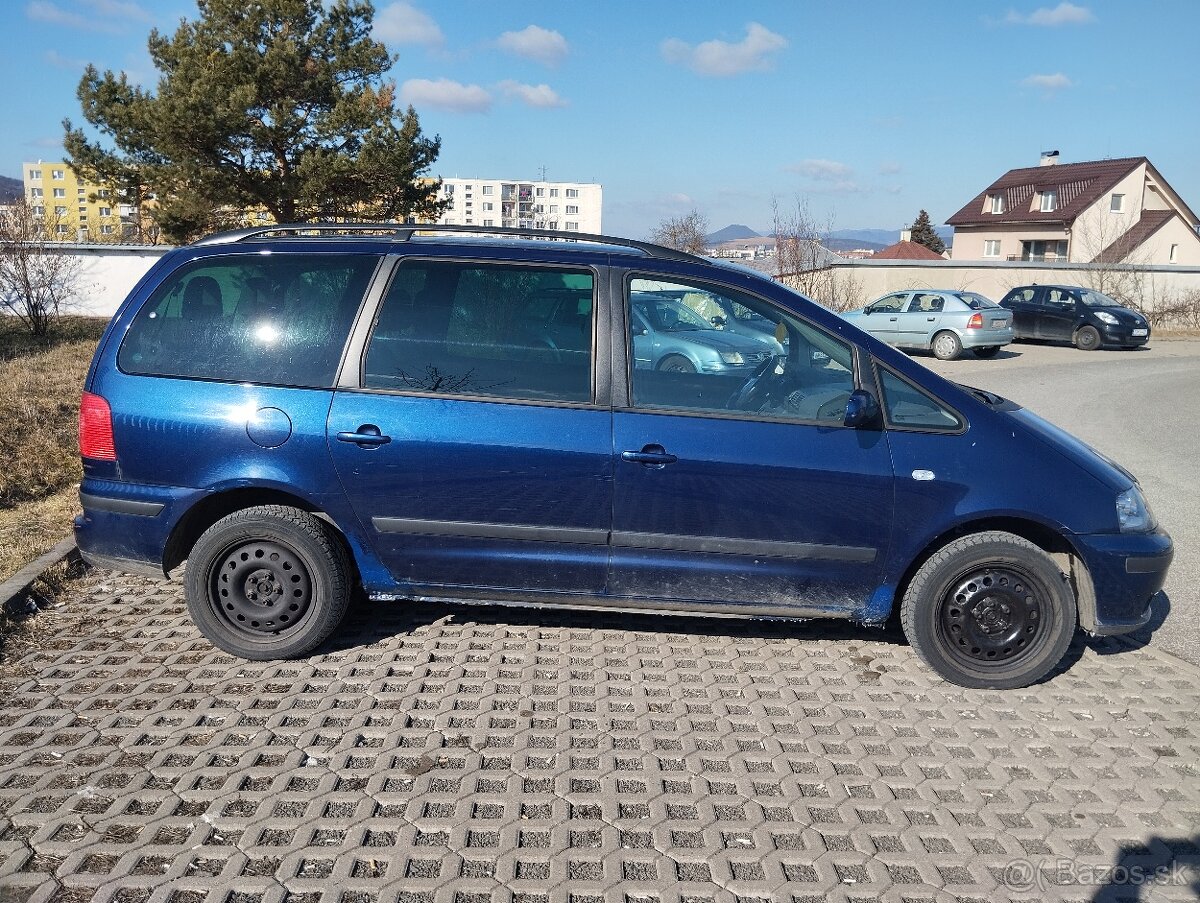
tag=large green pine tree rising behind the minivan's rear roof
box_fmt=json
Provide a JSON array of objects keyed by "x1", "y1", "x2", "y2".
[{"x1": 64, "y1": 0, "x2": 442, "y2": 240}]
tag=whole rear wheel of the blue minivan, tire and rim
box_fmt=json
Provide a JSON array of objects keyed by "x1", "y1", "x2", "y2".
[{"x1": 184, "y1": 504, "x2": 352, "y2": 660}]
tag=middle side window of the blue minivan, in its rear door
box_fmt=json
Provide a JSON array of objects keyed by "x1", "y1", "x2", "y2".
[{"x1": 362, "y1": 261, "x2": 595, "y2": 402}]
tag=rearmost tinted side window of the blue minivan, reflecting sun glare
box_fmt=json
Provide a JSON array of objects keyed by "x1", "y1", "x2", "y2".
[{"x1": 118, "y1": 253, "x2": 378, "y2": 388}]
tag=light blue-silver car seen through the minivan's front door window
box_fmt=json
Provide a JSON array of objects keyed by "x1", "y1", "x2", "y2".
[{"x1": 630, "y1": 292, "x2": 775, "y2": 373}]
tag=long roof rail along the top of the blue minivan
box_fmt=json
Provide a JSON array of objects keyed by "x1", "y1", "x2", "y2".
[{"x1": 192, "y1": 222, "x2": 707, "y2": 261}]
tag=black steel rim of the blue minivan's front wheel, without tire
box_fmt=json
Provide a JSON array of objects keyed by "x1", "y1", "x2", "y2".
[{"x1": 937, "y1": 566, "x2": 1048, "y2": 668}]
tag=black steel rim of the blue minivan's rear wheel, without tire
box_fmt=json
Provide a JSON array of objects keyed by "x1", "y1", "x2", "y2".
[{"x1": 209, "y1": 542, "x2": 312, "y2": 636}]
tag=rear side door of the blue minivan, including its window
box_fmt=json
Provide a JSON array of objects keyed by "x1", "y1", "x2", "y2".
[{"x1": 328, "y1": 258, "x2": 612, "y2": 597}]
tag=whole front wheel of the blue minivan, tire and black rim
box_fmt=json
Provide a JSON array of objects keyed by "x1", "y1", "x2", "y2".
[{"x1": 900, "y1": 531, "x2": 1078, "y2": 689}]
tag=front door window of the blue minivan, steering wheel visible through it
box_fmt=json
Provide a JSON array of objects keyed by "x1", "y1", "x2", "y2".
[{"x1": 628, "y1": 277, "x2": 854, "y2": 424}]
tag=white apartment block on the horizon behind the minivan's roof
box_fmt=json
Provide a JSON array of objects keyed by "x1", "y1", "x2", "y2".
[{"x1": 438, "y1": 178, "x2": 604, "y2": 233}]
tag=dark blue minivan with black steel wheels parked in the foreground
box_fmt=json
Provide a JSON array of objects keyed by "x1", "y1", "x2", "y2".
[{"x1": 76, "y1": 225, "x2": 1172, "y2": 688}]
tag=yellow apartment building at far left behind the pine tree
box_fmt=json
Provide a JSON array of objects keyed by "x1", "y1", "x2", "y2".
[{"x1": 20, "y1": 160, "x2": 144, "y2": 241}]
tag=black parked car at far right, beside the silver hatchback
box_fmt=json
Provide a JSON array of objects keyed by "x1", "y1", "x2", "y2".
[{"x1": 1000, "y1": 286, "x2": 1150, "y2": 351}]
